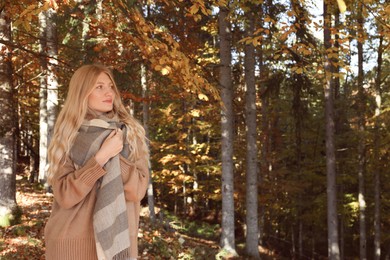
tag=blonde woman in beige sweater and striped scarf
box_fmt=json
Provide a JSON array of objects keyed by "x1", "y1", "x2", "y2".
[{"x1": 45, "y1": 64, "x2": 149, "y2": 260}]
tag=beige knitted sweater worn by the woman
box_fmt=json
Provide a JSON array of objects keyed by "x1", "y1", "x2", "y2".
[{"x1": 45, "y1": 154, "x2": 149, "y2": 260}]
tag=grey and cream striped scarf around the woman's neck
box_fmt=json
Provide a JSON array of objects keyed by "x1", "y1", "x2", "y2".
[{"x1": 70, "y1": 116, "x2": 130, "y2": 260}]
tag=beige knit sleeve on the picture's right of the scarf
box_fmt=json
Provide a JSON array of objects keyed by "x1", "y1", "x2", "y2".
[{"x1": 120, "y1": 156, "x2": 149, "y2": 202}]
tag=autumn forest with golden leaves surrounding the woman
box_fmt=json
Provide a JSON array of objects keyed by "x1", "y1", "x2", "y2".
[{"x1": 0, "y1": 0, "x2": 390, "y2": 260}]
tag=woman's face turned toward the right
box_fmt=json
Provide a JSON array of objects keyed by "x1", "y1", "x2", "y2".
[{"x1": 88, "y1": 72, "x2": 115, "y2": 115}]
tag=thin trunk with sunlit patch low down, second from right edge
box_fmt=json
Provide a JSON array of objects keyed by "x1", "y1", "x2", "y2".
[{"x1": 357, "y1": 2, "x2": 367, "y2": 260}]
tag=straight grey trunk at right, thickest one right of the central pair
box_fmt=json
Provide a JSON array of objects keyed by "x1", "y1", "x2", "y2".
[{"x1": 324, "y1": 0, "x2": 340, "y2": 260}]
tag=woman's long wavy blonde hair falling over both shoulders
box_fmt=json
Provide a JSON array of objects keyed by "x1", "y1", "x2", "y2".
[{"x1": 47, "y1": 64, "x2": 149, "y2": 184}]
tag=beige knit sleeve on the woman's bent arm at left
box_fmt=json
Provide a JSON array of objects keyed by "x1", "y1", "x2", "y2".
[{"x1": 52, "y1": 154, "x2": 106, "y2": 209}]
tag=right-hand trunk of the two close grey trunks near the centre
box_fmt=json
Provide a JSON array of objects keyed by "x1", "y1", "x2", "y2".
[{"x1": 244, "y1": 7, "x2": 260, "y2": 259}]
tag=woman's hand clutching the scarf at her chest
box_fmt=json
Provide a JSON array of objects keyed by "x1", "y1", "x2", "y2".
[{"x1": 95, "y1": 129, "x2": 123, "y2": 167}]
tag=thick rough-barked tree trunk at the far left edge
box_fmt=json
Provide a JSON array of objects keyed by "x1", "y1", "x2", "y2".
[{"x1": 0, "y1": 7, "x2": 18, "y2": 226}]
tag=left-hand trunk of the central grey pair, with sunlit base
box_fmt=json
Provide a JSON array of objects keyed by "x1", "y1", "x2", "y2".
[{"x1": 218, "y1": 7, "x2": 237, "y2": 255}]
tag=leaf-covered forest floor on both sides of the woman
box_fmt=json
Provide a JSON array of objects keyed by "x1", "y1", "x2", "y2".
[{"x1": 0, "y1": 176, "x2": 275, "y2": 260}]
